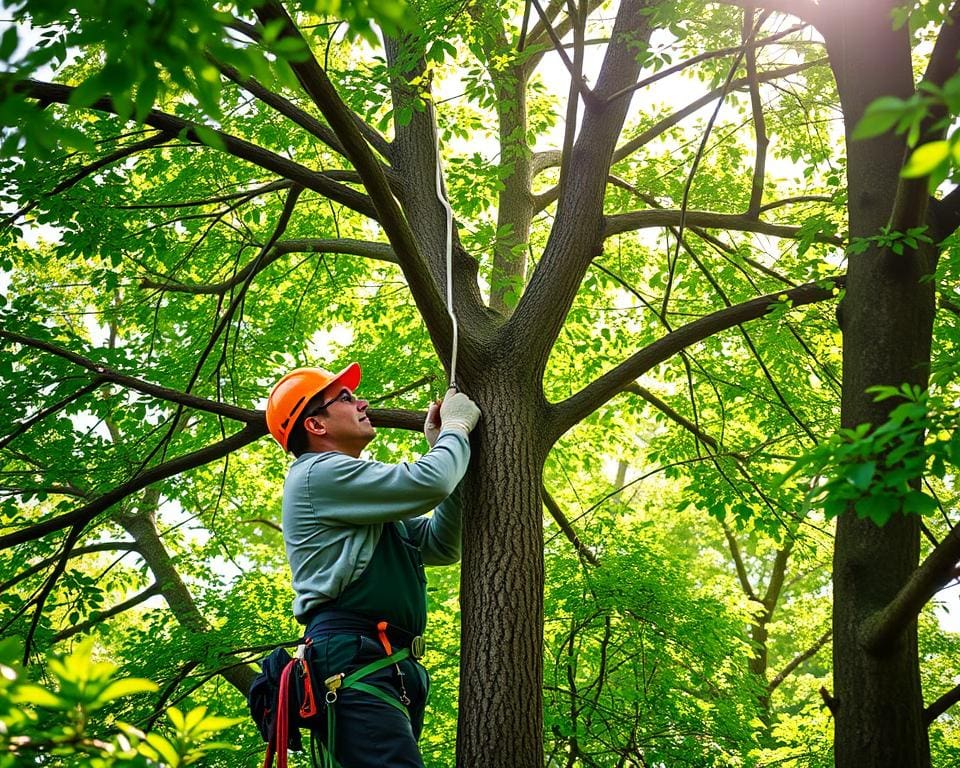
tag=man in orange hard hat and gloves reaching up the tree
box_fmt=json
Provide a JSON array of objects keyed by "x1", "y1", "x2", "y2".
[{"x1": 267, "y1": 363, "x2": 480, "y2": 768}]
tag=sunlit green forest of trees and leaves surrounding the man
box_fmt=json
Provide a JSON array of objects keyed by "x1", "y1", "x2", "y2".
[{"x1": 0, "y1": 0, "x2": 960, "y2": 768}]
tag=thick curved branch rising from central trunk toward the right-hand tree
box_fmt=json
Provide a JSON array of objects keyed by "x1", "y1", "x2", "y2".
[{"x1": 546, "y1": 277, "x2": 843, "y2": 440}]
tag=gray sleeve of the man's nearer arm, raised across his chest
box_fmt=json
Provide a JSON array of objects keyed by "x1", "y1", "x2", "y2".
[{"x1": 308, "y1": 430, "x2": 470, "y2": 528}]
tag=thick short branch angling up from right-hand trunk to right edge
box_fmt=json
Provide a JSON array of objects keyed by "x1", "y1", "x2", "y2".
[{"x1": 861, "y1": 527, "x2": 960, "y2": 654}]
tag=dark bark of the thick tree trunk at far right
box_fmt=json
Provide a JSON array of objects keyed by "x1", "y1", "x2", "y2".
[{"x1": 821, "y1": 0, "x2": 934, "y2": 768}]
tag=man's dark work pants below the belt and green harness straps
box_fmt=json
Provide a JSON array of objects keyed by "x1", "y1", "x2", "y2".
[{"x1": 315, "y1": 637, "x2": 429, "y2": 768}]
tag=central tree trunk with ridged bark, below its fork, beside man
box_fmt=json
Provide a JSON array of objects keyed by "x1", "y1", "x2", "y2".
[{"x1": 457, "y1": 366, "x2": 545, "y2": 768}]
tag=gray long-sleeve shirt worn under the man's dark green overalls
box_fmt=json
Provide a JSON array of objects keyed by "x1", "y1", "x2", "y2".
[{"x1": 283, "y1": 430, "x2": 470, "y2": 620}]
